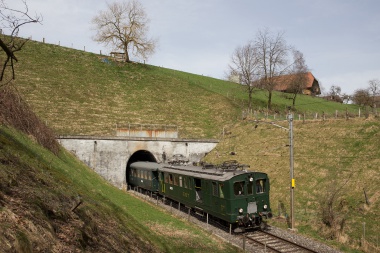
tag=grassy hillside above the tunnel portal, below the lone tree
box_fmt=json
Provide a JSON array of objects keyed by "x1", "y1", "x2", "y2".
[{"x1": 16, "y1": 41, "x2": 356, "y2": 138}]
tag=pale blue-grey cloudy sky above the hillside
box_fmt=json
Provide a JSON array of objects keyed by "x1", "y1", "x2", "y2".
[{"x1": 6, "y1": 0, "x2": 380, "y2": 94}]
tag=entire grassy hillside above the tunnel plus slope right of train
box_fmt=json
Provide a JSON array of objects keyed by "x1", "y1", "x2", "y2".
[{"x1": 8, "y1": 38, "x2": 380, "y2": 252}]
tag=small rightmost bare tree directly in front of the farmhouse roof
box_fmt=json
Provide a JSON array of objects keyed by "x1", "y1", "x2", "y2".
[{"x1": 288, "y1": 50, "x2": 309, "y2": 108}]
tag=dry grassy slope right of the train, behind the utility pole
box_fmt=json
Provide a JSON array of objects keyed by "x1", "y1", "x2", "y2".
[{"x1": 205, "y1": 119, "x2": 380, "y2": 252}]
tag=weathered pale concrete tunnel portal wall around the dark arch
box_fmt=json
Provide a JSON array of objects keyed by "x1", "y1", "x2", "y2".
[{"x1": 58, "y1": 136, "x2": 218, "y2": 189}]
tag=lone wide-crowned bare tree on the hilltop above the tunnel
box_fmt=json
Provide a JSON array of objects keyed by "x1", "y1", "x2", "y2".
[{"x1": 92, "y1": 0, "x2": 157, "y2": 62}]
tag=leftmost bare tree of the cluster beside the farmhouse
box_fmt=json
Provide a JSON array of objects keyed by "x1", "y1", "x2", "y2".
[{"x1": 229, "y1": 43, "x2": 259, "y2": 109}]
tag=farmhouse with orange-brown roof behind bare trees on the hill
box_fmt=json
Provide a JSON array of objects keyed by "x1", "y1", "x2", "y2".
[{"x1": 274, "y1": 72, "x2": 321, "y2": 96}]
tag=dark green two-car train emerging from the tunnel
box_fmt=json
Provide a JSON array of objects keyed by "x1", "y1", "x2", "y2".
[{"x1": 127, "y1": 161, "x2": 272, "y2": 232}]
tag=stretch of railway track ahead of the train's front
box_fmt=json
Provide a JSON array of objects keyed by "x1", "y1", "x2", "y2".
[{"x1": 244, "y1": 231, "x2": 318, "y2": 253}]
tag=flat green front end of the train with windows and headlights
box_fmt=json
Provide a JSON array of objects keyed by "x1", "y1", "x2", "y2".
[{"x1": 231, "y1": 172, "x2": 272, "y2": 232}]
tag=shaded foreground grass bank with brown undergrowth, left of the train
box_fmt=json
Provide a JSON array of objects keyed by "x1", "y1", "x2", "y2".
[{"x1": 0, "y1": 126, "x2": 238, "y2": 252}]
